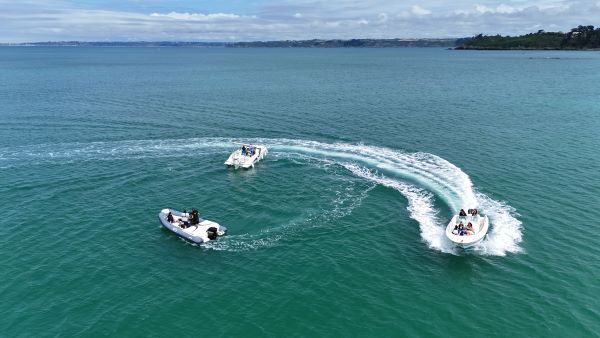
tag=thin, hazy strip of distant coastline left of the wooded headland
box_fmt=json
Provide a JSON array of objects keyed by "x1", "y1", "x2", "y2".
[{"x1": 0, "y1": 39, "x2": 464, "y2": 48}]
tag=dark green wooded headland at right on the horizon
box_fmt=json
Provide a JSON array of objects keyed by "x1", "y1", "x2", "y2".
[{"x1": 456, "y1": 26, "x2": 600, "y2": 50}]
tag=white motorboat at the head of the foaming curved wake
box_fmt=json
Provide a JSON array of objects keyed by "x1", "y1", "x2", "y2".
[{"x1": 446, "y1": 209, "x2": 490, "y2": 248}]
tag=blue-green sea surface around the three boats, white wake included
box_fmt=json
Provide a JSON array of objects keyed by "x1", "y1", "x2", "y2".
[{"x1": 0, "y1": 47, "x2": 600, "y2": 337}]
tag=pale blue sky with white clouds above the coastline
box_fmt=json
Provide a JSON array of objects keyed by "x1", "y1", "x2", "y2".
[{"x1": 0, "y1": 0, "x2": 600, "y2": 42}]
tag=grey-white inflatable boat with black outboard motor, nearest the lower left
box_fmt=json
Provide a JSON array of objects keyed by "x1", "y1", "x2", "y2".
[{"x1": 158, "y1": 209, "x2": 227, "y2": 244}]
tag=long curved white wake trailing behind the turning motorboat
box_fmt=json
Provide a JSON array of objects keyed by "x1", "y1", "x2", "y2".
[{"x1": 0, "y1": 138, "x2": 522, "y2": 255}]
